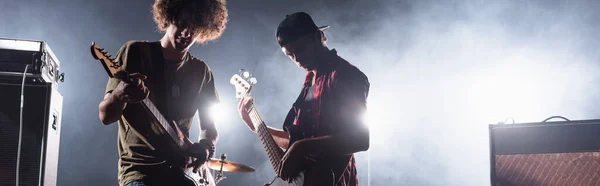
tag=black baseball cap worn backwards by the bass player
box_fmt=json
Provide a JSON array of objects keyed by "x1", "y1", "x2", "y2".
[{"x1": 277, "y1": 12, "x2": 329, "y2": 46}]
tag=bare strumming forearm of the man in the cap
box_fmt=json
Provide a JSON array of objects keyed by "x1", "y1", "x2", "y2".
[{"x1": 296, "y1": 130, "x2": 369, "y2": 156}]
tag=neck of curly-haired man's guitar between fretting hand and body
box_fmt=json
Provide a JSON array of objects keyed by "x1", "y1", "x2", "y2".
[{"x1": 142, "y1": 98, "x2": 190, "y2": 148}]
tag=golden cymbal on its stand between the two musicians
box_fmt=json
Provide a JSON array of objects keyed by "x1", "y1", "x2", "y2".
[{"x1": 206, "y1": 154, "x2": 254, "y2": 183}]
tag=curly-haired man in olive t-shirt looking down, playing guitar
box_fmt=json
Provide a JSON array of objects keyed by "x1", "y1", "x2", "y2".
[{"x1": 99, "y1": 0, "x2": 228, "y2": 186}]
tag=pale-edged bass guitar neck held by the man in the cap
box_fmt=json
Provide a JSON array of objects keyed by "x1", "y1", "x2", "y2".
[{"x1": 249, "y1": 103, "x2": 284, "y2": 170}]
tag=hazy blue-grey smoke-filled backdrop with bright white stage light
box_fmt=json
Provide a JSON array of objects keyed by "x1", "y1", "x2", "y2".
[{"x1": 0, "y1": 0, "x2": 600, "y2": 186}]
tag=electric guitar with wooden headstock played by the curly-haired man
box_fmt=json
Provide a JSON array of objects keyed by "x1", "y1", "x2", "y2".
[{"x1": 90, "y1": 43, "x2": 216, "y2": 186}]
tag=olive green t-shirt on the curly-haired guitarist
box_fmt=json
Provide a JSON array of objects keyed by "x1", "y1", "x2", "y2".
[{"x1": 106, "y1": 41, "x2": 219, "y2": 186}]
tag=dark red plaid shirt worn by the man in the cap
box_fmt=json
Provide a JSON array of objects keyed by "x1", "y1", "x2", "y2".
[{"x1": 283, "y1": 49, "x2": 370, "y2": 186}]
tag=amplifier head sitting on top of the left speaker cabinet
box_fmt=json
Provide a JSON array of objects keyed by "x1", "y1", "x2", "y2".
[{"x1": 0, "y1": 38, "x2": 64, "y2": 84}]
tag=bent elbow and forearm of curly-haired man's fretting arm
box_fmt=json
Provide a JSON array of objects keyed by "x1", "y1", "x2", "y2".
[{"x1": 98, "y1": 93, "x2": 127, "y2": 125}]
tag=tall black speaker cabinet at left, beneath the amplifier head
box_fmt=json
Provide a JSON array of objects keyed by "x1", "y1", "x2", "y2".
[{"x1": 0, "y1": 80, "x2": 63, "y2": 186}]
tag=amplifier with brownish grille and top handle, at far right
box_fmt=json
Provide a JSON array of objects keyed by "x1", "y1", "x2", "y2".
[{"x1": 489, "y1": 117, "x2": 600, "y2": 186}]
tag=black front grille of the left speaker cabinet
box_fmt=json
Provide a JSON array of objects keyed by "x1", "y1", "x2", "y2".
[{"x1": 0, "y1": 84, "x2": 49, "y2": 185}]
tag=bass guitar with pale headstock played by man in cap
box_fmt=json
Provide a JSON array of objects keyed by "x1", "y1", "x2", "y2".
[{"x1": 229, "y1": 69, "x2": 335, "y2": 186}]
